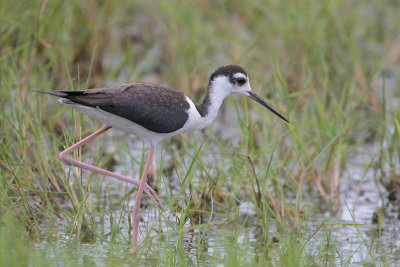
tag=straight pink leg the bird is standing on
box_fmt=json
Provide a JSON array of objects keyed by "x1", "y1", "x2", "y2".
[{"x1": 132, "y1": 144, "x2": 154, "y2": 251}]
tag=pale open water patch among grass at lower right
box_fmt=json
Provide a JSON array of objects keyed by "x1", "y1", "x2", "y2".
[{"x1": 305, "y1": 144, "x2": 400, "y2": 265}]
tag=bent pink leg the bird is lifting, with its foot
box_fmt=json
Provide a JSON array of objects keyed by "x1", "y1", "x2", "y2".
[{"x1": 59, "y1": 126, "x2": 161, "y2": 207}]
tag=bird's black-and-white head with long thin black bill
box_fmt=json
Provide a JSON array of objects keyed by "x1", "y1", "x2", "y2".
[{"x1": 208, "y1": 65, "x2": 289, "y2": 122}]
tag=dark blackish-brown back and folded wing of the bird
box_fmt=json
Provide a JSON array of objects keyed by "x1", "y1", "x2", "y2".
[{"x1": 53, "y1": 83, "x2": 190, "y2": 133}]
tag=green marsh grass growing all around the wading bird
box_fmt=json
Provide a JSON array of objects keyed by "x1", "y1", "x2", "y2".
[{"x1": 0, "y1": 0, "x2": 400, "y2": 266}]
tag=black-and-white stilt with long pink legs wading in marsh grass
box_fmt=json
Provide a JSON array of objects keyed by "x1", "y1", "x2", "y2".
[{"x1": 40, "y1": 65, "x2": 289, "y2": 250}]
